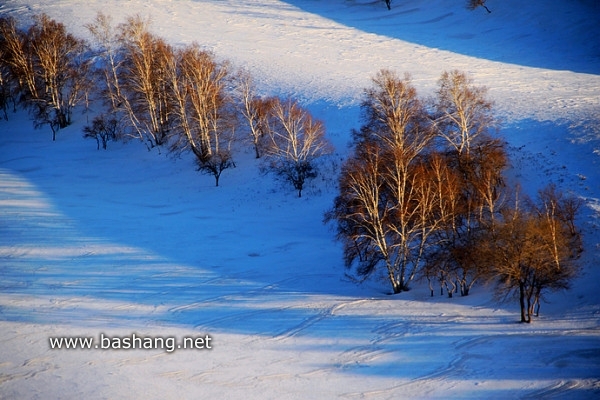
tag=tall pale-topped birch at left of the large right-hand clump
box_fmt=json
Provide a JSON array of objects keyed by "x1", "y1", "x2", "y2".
[{"x1": 326, "y1": 70, "x2": 442, "y2": 293}]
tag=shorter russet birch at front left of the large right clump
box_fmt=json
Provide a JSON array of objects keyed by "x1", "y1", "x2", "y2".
[{"x1": 326, "y1": 142, "x2": 444, "y2": 293}]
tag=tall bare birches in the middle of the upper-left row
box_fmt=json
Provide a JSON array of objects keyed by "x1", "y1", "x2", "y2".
[{"x1": 88, "y1": 14, "x2": 237, "y2": 186}]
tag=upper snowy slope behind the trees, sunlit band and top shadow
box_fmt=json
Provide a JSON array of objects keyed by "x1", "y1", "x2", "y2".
[{"x1": 0, "y1": 0, "x2": 600, "y2": 120}]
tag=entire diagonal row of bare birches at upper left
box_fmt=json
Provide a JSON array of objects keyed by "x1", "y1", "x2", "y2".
[{"x1": 0, "y1": 13, "x2": 332, "y2": 196}]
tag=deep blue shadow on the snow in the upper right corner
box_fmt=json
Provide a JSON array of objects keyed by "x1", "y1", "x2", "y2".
[{"x1": 286, "y1": 0, "x2": 600, "y2": 74}]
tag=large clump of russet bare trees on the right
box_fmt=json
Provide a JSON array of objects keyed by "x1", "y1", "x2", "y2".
[{"x1": 326, "y1": 70, "x2": 581, "y2": 322}]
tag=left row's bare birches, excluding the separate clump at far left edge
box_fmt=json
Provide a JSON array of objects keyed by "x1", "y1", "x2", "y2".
[{"x1": 88, "y1": 14, "x2": 331, "y2": 191}]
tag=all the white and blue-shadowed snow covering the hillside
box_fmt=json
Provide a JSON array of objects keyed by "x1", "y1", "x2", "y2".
[{"x1": 0, "y1": 0, "x2": 600, "y2": 399}]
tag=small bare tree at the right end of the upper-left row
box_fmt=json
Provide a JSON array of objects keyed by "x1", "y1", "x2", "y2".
[{"x1": 267, "y1": 99, "x2": 332, "y2": 197}]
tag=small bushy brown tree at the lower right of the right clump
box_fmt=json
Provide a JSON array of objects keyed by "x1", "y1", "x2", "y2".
[{"x1": 487, "y1": 188, "x2": 581, "y2": 323}]
